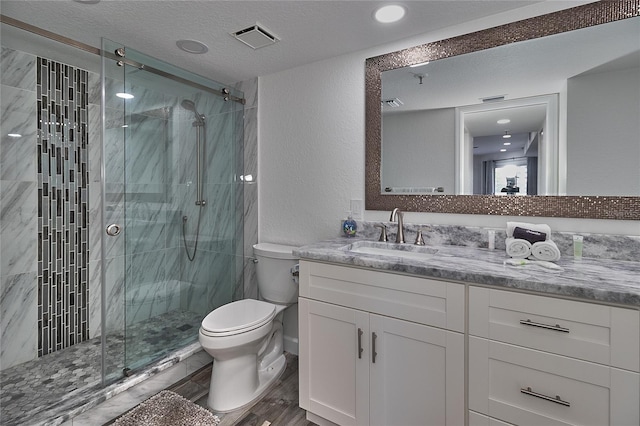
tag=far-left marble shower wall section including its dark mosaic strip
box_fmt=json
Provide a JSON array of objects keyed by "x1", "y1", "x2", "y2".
[{"x1": 0, "y1": 46, "x2": 96, "y2": 369}]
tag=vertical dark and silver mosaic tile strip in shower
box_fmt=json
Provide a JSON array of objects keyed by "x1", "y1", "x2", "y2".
[{"x1": 36, "y1": 57, "x2": 89, "y2": 357}]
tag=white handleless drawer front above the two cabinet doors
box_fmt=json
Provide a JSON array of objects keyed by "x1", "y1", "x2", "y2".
[{"x1": 300, "y1": 261, "x2": 465, "y2": 332}]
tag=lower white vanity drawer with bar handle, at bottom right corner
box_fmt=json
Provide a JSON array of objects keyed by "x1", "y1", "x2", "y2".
[{"x1": 469, "y1": 337, "x2": 640, "y2": 426}]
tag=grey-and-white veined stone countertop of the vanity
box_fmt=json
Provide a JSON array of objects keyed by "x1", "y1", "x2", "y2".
[{"x1": 294, "y1": 237, "x2": 640, "y2": 307}]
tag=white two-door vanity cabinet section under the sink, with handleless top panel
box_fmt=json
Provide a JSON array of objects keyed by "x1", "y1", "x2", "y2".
[{"x1": 299, "y1": 261, "x2": 465, "y2": 426}]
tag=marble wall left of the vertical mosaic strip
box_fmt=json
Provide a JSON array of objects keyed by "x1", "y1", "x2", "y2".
[{"x1": 0, "y1": 47, "x2": 38, "y2": 369}]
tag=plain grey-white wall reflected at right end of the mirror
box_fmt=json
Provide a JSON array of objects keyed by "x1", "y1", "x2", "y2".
[{"x1": 567, "y1": 68, "x2": 640, "y2": 196}]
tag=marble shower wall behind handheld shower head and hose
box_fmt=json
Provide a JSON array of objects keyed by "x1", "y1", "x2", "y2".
[{"x1": 174, "y1": 87, "x2": 242, "y2": 317}]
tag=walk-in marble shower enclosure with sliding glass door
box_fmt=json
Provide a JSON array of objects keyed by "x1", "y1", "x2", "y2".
[{"x1": 0, "y1": 16, "x2": 247, "y2": 424}]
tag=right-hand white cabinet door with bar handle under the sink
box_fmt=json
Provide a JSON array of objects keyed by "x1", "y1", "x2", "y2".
[{"x1": 369, "y1": 314, "x2": 464, "y2": 426}]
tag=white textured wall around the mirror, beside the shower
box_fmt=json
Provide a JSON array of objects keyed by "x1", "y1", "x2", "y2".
[{"x1": 258, "y1": 2, "x2": 640, "y2": 245}]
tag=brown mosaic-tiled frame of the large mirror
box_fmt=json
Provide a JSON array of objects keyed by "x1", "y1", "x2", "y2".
[{"x1": 365, "y1": 0, "x2": 640, "y2": 220}]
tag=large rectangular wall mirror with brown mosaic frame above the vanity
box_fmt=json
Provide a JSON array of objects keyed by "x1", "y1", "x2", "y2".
[{"x1": 366, "y1": 0, "x2": 640, "y2": 219}]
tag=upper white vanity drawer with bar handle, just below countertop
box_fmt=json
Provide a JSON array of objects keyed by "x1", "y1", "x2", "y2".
[{"x1": 469, "y1": 287, "x2": 640, "y2": 371}]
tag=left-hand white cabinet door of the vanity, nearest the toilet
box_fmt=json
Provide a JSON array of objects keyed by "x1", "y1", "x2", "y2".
[{"x1": 298, "y1": 298, "x2": 370, "y2": 426}]
